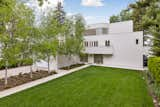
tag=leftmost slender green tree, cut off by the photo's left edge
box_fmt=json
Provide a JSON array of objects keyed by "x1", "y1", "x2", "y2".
[{"x1": 0, "y1": 0, "x2": 17, "y2": 85}]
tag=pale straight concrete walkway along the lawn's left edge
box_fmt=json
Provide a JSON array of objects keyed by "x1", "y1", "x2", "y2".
[{"x1": 0, "y1": 65, "x2": 90, "y2": 98}]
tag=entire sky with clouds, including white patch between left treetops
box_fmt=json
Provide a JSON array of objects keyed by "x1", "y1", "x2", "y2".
[{"x1": 27, "y1": 0, "x2": 136, "y2": 24}]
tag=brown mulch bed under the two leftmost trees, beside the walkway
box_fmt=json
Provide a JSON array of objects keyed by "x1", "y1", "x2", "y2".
[{"x1": 0, "y1": 71, "x2": 56, "y2": 91}]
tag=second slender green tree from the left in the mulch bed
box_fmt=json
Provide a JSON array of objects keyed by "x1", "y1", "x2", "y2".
[{"x1": 14, "y1": 4, "x2": 40, "y2": 78}]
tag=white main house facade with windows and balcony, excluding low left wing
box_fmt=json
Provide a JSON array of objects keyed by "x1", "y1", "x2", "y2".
[{"x1": 84, "y1": 21, "x2": 144, "y2": 70}]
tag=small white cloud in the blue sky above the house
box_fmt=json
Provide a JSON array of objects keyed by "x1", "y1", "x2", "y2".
[{"x1": 81, "y1": 0, "x2": 104, "y2": 7}]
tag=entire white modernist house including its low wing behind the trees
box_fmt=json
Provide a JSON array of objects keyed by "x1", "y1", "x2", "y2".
[{"x1": 37, "y1": 21, "x2": 146, "y2": 70}]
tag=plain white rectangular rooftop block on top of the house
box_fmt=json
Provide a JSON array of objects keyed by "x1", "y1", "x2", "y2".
[{"x1": 109, "y1": 21, "x2": 133, "y2": 34}]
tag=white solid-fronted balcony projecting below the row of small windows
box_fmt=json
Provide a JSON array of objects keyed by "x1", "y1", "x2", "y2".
[{"x1": 84, "y1": 46, "x2": 113, "y2": 55}]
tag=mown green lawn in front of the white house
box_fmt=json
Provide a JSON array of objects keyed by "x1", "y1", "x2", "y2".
[{"x1": 0, "y1": 66, "x2": 153, "y2": 107}]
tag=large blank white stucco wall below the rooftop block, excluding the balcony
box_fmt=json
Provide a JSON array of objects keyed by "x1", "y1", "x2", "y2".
[{"x1": 84, "y1": 32, "x2": 143, "y2": 70}]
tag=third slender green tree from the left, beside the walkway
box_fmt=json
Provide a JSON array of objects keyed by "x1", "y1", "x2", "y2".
[{"x1": 40, "y1": 11, "x2": 60, "y2": 73}]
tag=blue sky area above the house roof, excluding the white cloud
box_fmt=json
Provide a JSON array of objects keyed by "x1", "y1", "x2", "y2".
[{"x1": 64, "y1": 0, "x2": 135, "y2": 24}]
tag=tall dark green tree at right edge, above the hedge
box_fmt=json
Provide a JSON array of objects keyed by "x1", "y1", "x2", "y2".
[{"x1": 142, "y1": 0, "x2": 160, "y2": 56}]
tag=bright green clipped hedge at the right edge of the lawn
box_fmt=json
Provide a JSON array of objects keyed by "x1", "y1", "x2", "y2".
[{"x1": 148, "y1": 57, "x2": 160, "y2": 83}]
